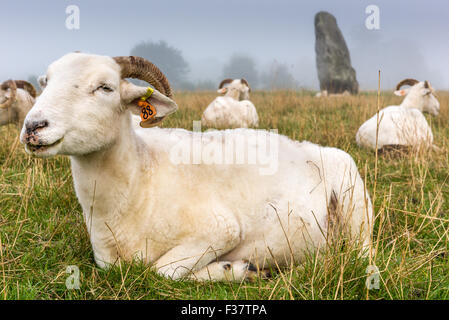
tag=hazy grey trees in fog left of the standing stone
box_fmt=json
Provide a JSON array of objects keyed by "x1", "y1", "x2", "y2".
[{"x1": 28, "y1": 40, "x2": 298, "y2": 91}]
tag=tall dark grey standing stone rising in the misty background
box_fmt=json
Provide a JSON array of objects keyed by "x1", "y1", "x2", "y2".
[{"x1": 315, "y1": 11, "x2": 359, "y2": 94}]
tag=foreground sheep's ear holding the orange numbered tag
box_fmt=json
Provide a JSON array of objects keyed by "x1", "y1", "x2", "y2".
[{"x1": 120, "y1": 80, "x2": 178, "y2": 127}]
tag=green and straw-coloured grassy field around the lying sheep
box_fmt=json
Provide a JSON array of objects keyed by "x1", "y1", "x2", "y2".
[{"x1": 0, "y1": 91, "x2": 449, "y2": 299}]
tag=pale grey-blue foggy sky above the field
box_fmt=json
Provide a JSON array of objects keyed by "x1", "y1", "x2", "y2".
[{"x1": 0, "y1": 0, "x2": 449, "y2": 89}]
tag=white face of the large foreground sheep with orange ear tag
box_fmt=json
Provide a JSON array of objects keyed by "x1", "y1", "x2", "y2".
[{"x1": 20, "y1": 53, "x2": 176, "y2": 157}]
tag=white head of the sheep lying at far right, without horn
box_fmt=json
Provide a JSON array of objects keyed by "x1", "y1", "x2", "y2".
[{"x1": 394, "y1": 81, "x2": 440, "y2": 116}]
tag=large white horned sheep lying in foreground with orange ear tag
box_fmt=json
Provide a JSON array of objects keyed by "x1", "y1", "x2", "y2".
[{"x1": 21, "y1": 53, "x2": 373, "y2": 280}]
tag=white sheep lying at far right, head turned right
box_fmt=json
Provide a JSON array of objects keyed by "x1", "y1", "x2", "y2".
[{"x1": 356, "y1": 79, "x2": 440, "y2": 149}]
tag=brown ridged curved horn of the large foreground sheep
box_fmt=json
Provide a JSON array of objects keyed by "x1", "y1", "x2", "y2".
[{"x1": 114, "y1": 56, "x2": 173, "y2": 98}]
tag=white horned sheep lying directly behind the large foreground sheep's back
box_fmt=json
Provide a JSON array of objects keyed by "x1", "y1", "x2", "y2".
[{"x1": 201, "y1": 79, "x2": 259, "y2": 128}]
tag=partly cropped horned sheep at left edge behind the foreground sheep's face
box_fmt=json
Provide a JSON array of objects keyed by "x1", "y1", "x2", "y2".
[{"x1": 0, "y1": 80, "x2": 36, "y2": 127}]
